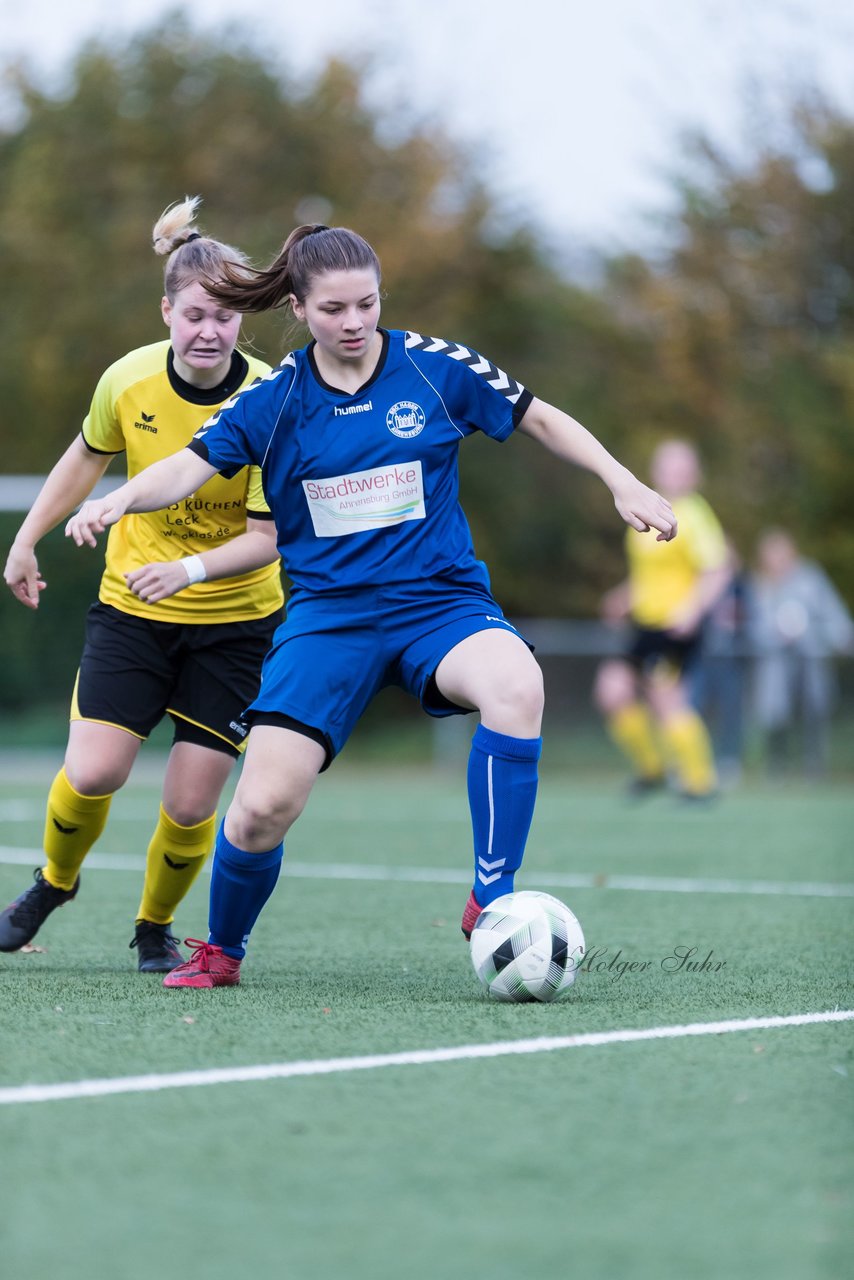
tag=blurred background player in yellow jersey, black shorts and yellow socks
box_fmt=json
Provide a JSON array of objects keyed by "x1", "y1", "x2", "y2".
[{"x1": 594, "y1": 440, "x2": 729, "y2": 800}]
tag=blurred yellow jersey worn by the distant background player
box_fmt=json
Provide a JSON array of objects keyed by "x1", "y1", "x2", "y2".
[{"x1": 626, "y1": 493, "x2": 726, "y2": 630}]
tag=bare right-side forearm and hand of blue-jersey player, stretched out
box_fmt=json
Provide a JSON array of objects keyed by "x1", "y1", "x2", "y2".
[{"x1": 519, "y1": 398, "x2": 676, "y2": 541}]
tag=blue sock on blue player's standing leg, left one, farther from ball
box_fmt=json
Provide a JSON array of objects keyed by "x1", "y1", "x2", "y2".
[{"x1": 207, "y1": 820, "x2": 284, "y2": 960}]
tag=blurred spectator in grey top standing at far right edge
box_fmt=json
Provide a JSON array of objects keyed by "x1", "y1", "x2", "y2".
[{"x1": 749, "y1": 529, "x2": 854, "y2": 777}]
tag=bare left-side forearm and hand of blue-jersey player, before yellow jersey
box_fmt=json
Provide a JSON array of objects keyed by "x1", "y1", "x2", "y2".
[{"x1": 65, "y1": 449, "x2": 216, "y2": 547}]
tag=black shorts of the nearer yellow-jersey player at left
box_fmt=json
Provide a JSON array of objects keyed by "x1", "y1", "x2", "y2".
[{"x1": 72, "y1": 602, "x2": 282, "y2": 756}]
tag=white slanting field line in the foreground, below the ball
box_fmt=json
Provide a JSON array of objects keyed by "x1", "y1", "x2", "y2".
[{"x1": 0, "y1": 1009, "x2": 854, "y2": 1106}]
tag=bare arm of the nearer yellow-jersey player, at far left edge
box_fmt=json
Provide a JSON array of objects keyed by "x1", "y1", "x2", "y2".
[{"x1": 4, "y1": 435, "x2": 111, "y2": 609}]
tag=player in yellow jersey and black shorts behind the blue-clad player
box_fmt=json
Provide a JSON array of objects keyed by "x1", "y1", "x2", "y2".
[{"x1": 0, "y1": 197, "x2": 283, "y2": 973}]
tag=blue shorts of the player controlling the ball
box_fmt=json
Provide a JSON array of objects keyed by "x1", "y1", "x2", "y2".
[{"x1": 245, "y1": 581, "x2": 519, "y2": 767}]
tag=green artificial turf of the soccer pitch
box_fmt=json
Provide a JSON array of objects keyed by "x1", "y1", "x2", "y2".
[{"x1": 0, "y1": 759, "x2": 854, "y2": 1280}]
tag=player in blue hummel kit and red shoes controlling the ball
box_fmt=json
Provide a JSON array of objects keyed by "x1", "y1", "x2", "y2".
[{"x1": 67, "y1": 227, "x2": 676, "y2": 987}]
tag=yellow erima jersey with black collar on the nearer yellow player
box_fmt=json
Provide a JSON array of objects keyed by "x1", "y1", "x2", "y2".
[{"x1": 83, "y1": 339, "x2": 283, "y2": 622}]
